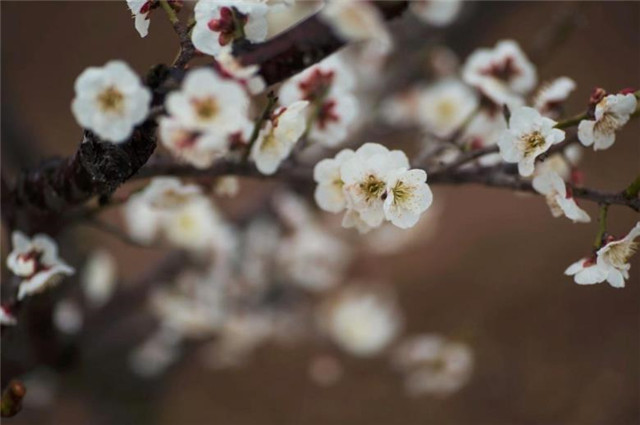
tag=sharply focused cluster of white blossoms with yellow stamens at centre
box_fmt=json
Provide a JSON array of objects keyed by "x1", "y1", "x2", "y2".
[{"x1": 313, "y1": 143, "x2": 433, "y2": 232}]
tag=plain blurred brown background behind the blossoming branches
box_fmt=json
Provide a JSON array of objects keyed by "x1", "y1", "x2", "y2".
[{"x1": 0, "y1": 1, "x2": 640, "y2": 425}]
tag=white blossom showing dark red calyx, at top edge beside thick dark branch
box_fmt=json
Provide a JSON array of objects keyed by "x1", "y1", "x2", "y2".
[{"x1": 191, "y1": 0, "x2": 269, "y2": 56}]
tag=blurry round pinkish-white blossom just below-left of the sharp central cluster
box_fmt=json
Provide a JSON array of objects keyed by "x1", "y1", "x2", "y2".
[{"x1": 277, "y1": 227, "x2": 351, "y2": 292}]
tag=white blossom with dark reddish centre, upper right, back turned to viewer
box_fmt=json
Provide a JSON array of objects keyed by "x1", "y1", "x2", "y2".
[{"x1": 462, "y1": 40, "x2": 537, "y2": 108}]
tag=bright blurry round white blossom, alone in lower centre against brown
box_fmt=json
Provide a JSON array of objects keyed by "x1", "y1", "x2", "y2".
[{"x1": 320, "y1": 286, "x2": 402, "y2": 357}]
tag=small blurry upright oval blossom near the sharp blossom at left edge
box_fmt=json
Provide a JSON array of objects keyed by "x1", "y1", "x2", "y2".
[{"x1": 82, "y1": 249, "x2": 118, "y2": 307}]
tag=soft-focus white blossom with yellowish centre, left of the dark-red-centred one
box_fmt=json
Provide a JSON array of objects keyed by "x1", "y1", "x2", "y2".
[{"x1": 418, "y1": 79, "x2": 478, "y2": 138}]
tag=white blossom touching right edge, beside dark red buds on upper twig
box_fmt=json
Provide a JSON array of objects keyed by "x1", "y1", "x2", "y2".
[{"x1": 578, "y1": 94, "x2": 638, "y2": 150}]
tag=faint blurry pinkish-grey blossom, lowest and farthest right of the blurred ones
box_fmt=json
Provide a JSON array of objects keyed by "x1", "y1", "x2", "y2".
[{"x1": 393, "y1": 334, "x2": 473, "y2": 396}]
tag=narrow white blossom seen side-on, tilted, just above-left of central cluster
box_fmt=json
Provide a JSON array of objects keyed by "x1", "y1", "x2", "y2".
[{"x1": 251, "y1": 101, "x2": 309, "y2": 174}]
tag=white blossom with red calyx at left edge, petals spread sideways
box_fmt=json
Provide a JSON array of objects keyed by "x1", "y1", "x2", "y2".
[{"x1": 7, "y1": 231, "x2": 75, "y2": 300}]
